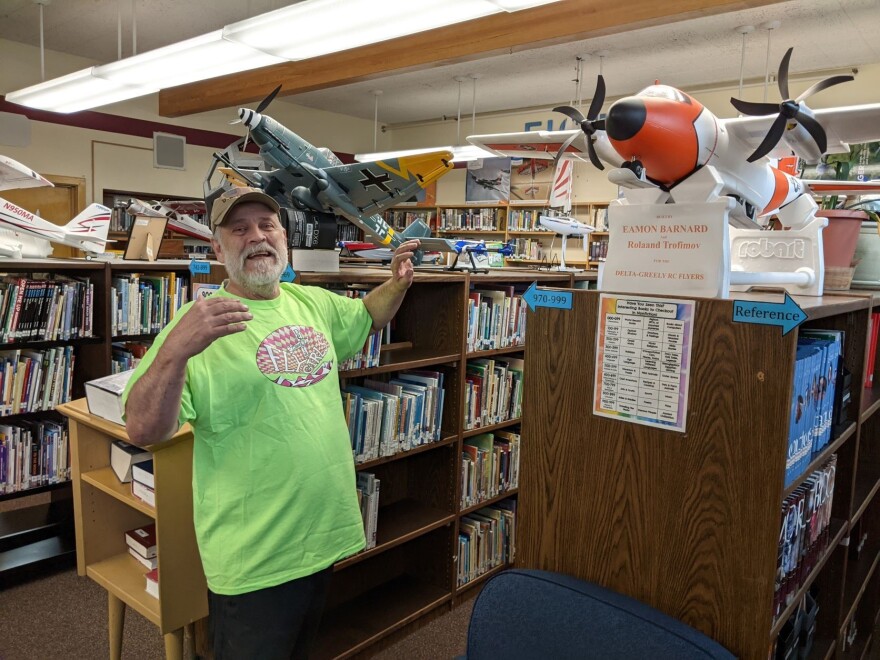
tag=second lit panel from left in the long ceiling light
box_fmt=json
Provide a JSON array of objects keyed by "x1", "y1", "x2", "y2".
[{"x1": 94, "y1": 30, "x2": 284, "y2": 89}]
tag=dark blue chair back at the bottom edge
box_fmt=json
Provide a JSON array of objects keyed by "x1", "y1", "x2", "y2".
[{"x1": 465, "y1": 569, "x2": 735, "y2": 660}]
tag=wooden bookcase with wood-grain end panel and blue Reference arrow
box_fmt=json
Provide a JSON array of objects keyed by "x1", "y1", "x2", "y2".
[{"x1": 516, "y1": 291, "x2": 880, "y2": 659}]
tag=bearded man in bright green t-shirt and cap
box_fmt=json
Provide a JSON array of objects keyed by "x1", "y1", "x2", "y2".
[{"x1": 124, "y1": 188, "x2": 418, "y2": 660}]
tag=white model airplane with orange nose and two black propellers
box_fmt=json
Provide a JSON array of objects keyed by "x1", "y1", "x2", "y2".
[{"x1": 468, "y1": 49, "x2": 880, "y2": 226}]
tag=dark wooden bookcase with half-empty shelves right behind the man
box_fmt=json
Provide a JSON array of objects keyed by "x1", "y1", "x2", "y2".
[{"x1": 298, "y1": 268, "x2": 571, "y2": 658}]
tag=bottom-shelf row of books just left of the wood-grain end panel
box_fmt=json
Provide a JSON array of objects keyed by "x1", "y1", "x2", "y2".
[{"x1": 457, "y1": 499, "x2": 516, "y2": 586}]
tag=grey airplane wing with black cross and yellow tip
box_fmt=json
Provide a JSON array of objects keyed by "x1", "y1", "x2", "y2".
[{"x1": 324, "y1": 151, "x2": 453, "y2": 214}]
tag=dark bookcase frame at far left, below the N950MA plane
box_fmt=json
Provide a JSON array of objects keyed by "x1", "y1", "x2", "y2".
[{"x1": 0, "y1": 259, "x2": 106, "y2": 584}]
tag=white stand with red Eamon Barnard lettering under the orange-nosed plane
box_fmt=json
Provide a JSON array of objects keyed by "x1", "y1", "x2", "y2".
[{"x1": 598, "y1": 166, "x2": 825, "y2": 298}]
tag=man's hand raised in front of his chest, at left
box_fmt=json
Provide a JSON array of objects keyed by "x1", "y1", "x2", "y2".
[{"x1": 163, "y1": 296, "x2": 253, "y2": 360}]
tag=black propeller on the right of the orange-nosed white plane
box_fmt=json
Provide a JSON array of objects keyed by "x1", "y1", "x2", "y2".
[{"x1": 730, "y1": 48, "x2": 853, "y2": 163}]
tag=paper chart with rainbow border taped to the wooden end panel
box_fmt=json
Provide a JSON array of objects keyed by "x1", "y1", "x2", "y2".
[{"x1": 593, "y1": 293, "x2": 694, "y2": 432}]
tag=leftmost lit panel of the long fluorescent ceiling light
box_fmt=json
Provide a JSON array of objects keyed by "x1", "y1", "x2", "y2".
[{"x1": 6, "y1": 67, "x2": 158, "y2": 112}]
